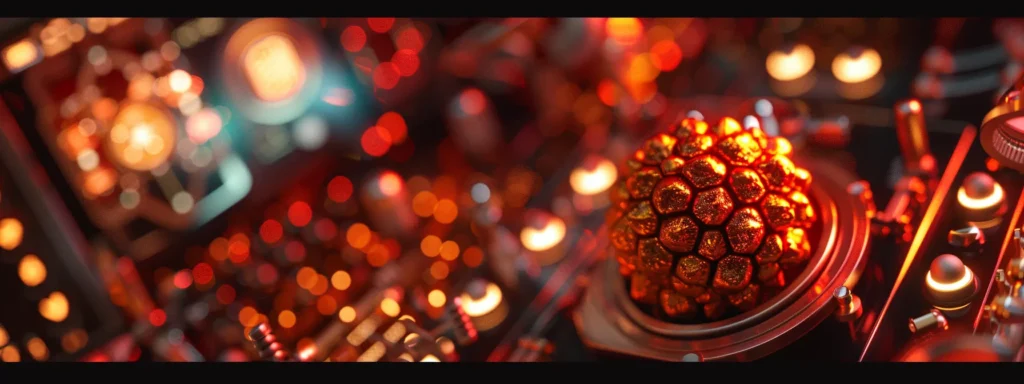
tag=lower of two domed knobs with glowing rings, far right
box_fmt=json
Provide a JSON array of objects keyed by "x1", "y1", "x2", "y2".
[{"x1": 925, "y1": 254, "x2": 978, "y2": 316}]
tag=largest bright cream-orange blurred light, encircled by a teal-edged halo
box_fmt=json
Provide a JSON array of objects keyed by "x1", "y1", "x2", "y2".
[{"x1": 242, "y1": 34, "x2": 306, "y2": 102}]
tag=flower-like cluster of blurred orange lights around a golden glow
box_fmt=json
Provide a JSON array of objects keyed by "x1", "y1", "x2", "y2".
[{"x1": 48, "y1": 36, "x2": 224, "y2": 213}]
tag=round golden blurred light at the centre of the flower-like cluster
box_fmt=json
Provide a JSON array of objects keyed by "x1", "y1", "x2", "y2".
[{"x1": 106, "y1": 102, "x2": 177, "y2": 171}]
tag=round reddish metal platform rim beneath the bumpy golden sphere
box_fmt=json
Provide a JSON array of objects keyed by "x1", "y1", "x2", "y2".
[{"x1": 574, "y1": 157, "x2": 869, "y2": 361}]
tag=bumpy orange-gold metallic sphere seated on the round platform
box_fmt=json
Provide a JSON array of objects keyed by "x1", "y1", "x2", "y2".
[{"x1": 606, "y1": 115, "x2": 816, "y2": 322}]
